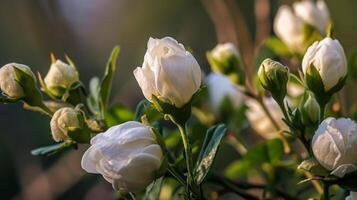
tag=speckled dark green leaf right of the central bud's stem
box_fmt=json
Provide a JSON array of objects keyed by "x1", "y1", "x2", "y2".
[{"x1": 195, "y1": 124, "x2": 227, "y2": 184}]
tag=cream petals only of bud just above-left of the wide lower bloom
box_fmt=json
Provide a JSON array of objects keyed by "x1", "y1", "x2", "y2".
[{"x1": 50, "y1": 107, "x2": 81, "y2": 142}]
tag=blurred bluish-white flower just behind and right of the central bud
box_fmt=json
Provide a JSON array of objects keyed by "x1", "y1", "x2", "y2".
[{"x1": 206, "y1": 73, "x2": 244, "y2": 113}]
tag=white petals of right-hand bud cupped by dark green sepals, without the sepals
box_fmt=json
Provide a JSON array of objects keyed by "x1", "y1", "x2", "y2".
[{"x1": 302, "y1": 37, "x2": 347, "y2": 91}]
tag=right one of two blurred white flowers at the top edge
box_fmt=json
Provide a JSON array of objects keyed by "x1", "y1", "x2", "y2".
[{"x1": 293, "y1": 0, "x2": 330, "y2": 34}]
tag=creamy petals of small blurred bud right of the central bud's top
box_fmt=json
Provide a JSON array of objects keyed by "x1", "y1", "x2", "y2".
[{"x1": 211, "y1": 43, "x2": 240, "y2": 61}]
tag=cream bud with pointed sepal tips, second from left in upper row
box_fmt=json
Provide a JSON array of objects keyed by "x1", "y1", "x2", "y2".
[{"x1": 44, "y1": 60, "x2": 79, "y2": 98}]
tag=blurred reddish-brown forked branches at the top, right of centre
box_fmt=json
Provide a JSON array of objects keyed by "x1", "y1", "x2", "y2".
[{"x1": 201, "y1": 0, "x2": 271, "y2": 78}]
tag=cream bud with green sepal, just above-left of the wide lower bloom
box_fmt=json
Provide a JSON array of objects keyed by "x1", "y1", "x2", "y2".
[{"x1": 50, "y1": 107, "x2": 89, "y2": 143}]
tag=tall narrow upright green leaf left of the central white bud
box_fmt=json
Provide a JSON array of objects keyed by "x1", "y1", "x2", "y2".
[{"x1": 99, "y1": 46, "x2": 119, "y2": 117}]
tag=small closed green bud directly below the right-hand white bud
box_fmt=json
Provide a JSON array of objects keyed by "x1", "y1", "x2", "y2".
[{"x1": 299, "y1": 92, "x2": 320, "y2": 125}]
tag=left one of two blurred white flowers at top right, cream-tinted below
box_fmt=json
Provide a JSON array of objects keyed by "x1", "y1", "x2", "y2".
[{"x1": 274, "y1": 5, "x2": 305, "y2": 53}]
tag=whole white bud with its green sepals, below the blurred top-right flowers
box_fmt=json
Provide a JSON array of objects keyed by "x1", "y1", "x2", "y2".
[{"x1": 302, "y1": 37, "x2": 347, "y2": 97}]
